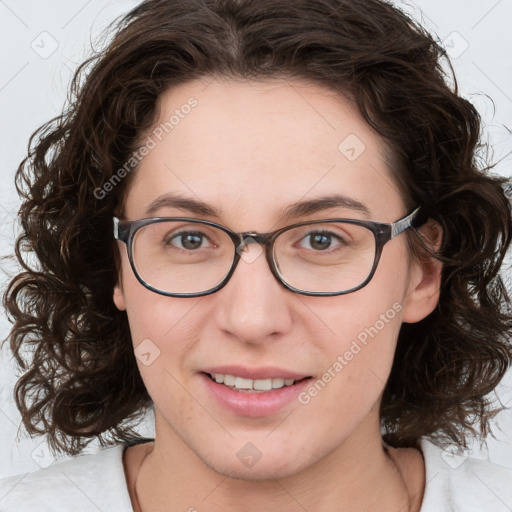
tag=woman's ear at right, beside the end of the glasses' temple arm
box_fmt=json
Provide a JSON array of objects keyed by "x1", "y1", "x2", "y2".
[{"x1": 402, "y1": 220, "x2": 443, "y2": 323}]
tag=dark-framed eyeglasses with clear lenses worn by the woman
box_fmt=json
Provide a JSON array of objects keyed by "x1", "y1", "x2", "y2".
[{"x1": 114, "y1": 208, "x2": 426, "y2": 297}]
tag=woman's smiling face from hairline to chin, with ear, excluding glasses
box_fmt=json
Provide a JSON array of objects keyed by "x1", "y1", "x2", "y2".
[{"x1": 114, "y1": 80, "x2": 436, "y2": 479}]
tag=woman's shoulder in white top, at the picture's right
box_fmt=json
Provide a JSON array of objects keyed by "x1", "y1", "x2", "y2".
[{"x1": 420, "y1": 439, "x2": 512, "y2": 512}]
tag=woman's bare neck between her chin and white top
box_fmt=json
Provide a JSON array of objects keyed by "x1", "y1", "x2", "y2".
[{"x1": 129, "y1": 420, "x2": 424, "y2": 512}]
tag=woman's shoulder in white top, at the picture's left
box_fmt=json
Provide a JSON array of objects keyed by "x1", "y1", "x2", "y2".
[{"x1": 0, "y1": 444, "x2": 132, "y2": 512}]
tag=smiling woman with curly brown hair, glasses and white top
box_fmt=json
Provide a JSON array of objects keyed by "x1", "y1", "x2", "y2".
[{"x1": 0, "y1": 0, "x2": 512, "y2": 512}]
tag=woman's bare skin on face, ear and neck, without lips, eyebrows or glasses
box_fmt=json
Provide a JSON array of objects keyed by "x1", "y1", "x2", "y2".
[{"x1": 114, "y1": 79, "x2": 441, "y2": 512}]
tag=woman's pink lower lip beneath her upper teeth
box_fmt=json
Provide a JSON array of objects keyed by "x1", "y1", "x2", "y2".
[{"x1": 201, "y1": 373, "x2": 311, "y2": 417}]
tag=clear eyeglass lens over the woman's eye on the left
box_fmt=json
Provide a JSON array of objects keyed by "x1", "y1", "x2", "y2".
[{"x1": 133, "y1": 221, "x2": 235, "y2": 293}]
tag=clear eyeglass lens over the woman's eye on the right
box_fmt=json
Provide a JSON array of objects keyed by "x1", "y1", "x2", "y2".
[{"x1": 274, "y1": 222, "x2": 376, "y2": 292}]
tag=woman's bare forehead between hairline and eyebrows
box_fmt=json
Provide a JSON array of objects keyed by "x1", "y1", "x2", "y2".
[{"x1": 125, "y1": 79, "x2": 402, "y2": 228}]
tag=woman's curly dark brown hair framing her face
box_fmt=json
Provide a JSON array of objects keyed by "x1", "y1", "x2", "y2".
[{"x1": 4, "y1": 0, "x2": 512, "y2": 454}]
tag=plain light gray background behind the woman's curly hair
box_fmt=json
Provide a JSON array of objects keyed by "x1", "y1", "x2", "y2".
[{"x1": 0, "y1": 0, "x2": 512, "y2": 477}]
